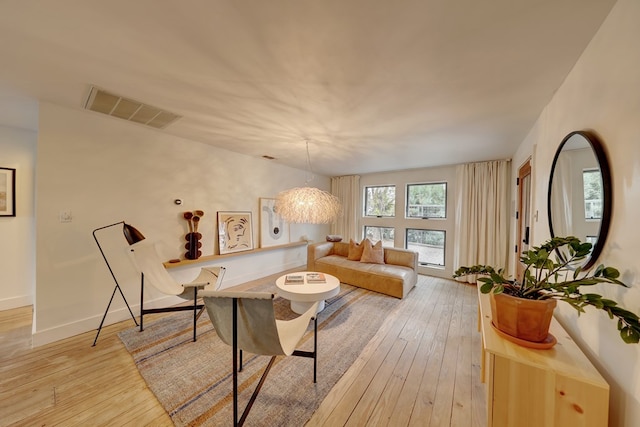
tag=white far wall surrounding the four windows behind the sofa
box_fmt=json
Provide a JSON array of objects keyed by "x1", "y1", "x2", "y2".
[{"x1": 358, "y1": 165, "x2": 456, "y2": 279}]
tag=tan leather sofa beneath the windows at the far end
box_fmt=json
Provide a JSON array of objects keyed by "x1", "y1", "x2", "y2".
[{"x1": 307, "y1": 242, "x2": 418, "y2": 298}]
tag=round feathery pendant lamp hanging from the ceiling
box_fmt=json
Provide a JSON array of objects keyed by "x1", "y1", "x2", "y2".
[{"x1": 274, "y1": 140, "x2": 342, "y2": 224}]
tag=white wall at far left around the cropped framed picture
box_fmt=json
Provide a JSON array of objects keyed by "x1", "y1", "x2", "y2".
[{"x1": 0, "y1": 126, "x2": 37, "y2": 310}]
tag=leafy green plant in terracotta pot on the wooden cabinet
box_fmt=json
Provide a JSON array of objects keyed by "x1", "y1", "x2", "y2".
[{"x1": 453, "y1": 236, "x2": 640, "y2": 343}]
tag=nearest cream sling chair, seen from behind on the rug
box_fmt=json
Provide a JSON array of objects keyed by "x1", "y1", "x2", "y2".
[{"x1": 200, "y1": 291, "x2": 318, "y2": 426}]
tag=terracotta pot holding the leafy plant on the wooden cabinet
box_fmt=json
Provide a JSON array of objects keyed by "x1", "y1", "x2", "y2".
[{"x1": 491, "y1": 293, "x2": 557, "y2": 342}]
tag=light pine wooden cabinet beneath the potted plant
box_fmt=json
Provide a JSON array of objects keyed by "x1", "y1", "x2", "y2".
[{"x1": 478, "y1": 288, "x2": 609, "y2": 427}]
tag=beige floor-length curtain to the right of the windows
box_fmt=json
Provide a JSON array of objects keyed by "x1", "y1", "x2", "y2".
[{"x1": 453, "y1": 160, "x2": 511, "y2": 280}]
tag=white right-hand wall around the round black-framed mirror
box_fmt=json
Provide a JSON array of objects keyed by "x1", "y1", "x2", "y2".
[{"x1": 514, "y1": 0, "x2": 640, "y2": 427}]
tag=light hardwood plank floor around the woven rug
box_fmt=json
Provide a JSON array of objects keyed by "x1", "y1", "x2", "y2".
[{"x1": 0, "y1": 275, "x2": 486, "y2": 427}]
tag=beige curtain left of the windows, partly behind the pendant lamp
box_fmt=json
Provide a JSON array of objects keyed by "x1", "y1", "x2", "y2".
[{"x1": 331, "y1": 175, "x2": 360, "y2": 242}]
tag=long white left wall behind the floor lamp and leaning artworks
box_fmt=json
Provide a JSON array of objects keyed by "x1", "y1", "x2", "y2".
[{"x1": 34, "y1": 103, "x2": 329, "y2": 345}]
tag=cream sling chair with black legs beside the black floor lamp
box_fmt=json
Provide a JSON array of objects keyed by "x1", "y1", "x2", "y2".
[{"x1": 131, "y1": 242, "x2": 225, "y2": 341}]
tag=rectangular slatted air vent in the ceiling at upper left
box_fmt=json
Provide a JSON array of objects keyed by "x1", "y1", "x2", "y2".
[{"x1": 84, "y1": 86, "x2": 182, "y2": 129}]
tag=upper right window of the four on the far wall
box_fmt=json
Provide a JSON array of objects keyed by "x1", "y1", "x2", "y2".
[{"x1": 406, "y1": 182, "x2": 447, "y2": 219}]
